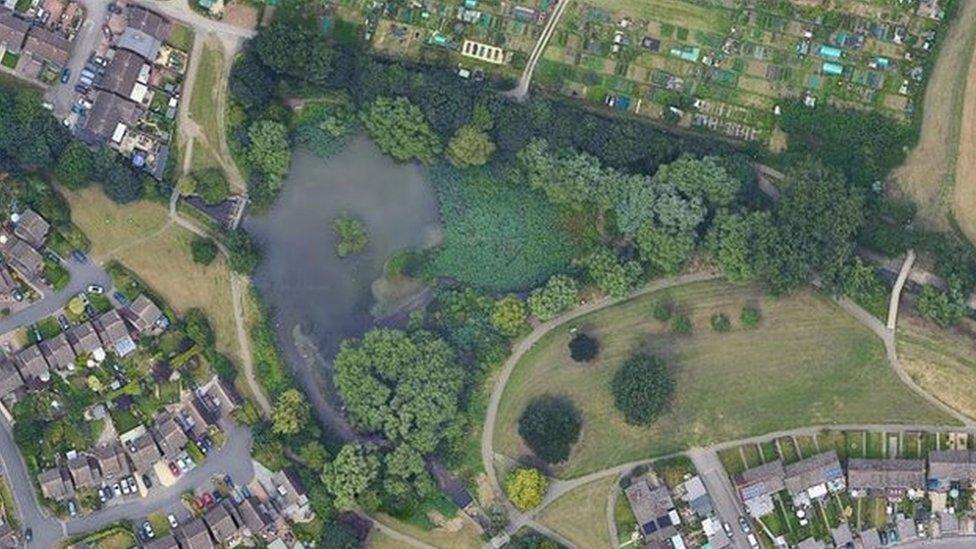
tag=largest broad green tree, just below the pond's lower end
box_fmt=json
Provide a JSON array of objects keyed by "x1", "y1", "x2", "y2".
[{"x1": 334, "y1": 329, "x2": 464, "y2": 454}]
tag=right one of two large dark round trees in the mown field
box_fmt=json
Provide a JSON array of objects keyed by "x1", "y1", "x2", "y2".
[{"x1": 611, "y1": 354, "x2": 674, "y2": 425}]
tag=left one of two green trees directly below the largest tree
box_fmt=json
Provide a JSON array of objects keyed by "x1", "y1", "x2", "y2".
[{"x1": 321, "y1": 443, "x2": 380, "y2": 511}]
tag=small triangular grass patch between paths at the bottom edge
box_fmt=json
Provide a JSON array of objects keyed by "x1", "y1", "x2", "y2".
[{"x1": 536, "y1": 476, "x2": 612, "y2": 548}]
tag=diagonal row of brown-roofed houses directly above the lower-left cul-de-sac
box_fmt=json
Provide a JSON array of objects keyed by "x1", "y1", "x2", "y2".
[{"x1": 37, "y1": 377, "x2": 240, "y2": 501}]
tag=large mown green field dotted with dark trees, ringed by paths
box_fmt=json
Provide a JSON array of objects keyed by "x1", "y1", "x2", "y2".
[{"x1": 495, "y1": 281, "x2": 951, "y2": 477}]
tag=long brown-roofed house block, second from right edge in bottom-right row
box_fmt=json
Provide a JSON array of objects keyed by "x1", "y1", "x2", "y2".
[{"x1": 847, "y1": 459, "x2": 925, "y2": 500}]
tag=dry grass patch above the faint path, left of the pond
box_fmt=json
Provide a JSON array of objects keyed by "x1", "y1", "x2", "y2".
[{"x1": 65, "y1": 186, "x2": 167, "y2": 259}]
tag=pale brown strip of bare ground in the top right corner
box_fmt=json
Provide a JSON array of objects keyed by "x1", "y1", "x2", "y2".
[{"x1": 892, "y1": 0, "x2": 976, "y2": 231}]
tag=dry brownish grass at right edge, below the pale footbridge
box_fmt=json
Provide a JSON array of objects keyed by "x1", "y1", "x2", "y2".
[{"x1": 897, "y1": 314, "x2": 976, "y2": 417}]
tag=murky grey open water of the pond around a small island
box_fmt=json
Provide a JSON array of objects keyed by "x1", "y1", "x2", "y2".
[{"x1": 244, "y1": 136, "x2": 440, "y2": 436}]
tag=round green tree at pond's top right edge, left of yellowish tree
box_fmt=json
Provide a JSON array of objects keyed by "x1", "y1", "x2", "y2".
[{"x1": 361, "y1": 97, "x2": 441, "y2": 164}]
